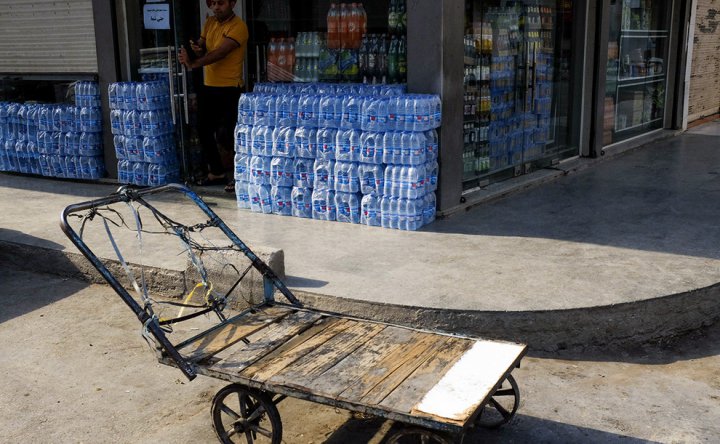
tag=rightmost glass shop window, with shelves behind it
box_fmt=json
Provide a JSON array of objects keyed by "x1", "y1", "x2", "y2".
[{"x1": 603, "y1": 0, "x2": 672, "y2": 145}]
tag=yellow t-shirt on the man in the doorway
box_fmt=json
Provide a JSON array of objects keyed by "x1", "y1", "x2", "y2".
[{"x1": 200, "y1": 16, "x2": 248, "y2": 86}]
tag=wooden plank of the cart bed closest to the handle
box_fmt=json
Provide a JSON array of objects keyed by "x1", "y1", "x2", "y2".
[{"x1": 181, "y1": 307, "x2": 294, "y2": 362}]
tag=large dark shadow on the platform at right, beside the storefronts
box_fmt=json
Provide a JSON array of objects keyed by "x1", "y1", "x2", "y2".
[{"x1": 422, "y1": 134, "x2": 720, "y2": 259}]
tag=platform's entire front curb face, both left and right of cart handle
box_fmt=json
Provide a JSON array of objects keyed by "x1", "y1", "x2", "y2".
[{"x1": 5, "y1": 241, "x2": 720, "y2": 352}]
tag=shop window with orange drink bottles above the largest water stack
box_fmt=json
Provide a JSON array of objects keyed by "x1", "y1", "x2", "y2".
[{"x1": 247, "y1": 0, "x2": 407, "y2": 87}]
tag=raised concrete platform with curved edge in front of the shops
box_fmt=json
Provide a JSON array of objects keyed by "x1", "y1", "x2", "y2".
[{"x1": 0, "y1": 121, "x2": 720, "y2": 349}]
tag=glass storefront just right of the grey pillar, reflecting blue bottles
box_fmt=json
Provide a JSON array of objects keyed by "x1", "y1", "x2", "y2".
[{"x1": 463, "y1": 0, "x2": 577, "y2": 189}]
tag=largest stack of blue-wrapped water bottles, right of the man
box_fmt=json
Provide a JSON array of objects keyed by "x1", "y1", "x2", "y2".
[{"x1": 235, "y1": 83, "x2": 441, "y2": 230}]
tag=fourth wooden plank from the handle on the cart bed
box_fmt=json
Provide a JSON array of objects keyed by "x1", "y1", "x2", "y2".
[{"x1": 270, "y1": 322, "x2": 386, "y2": 388}]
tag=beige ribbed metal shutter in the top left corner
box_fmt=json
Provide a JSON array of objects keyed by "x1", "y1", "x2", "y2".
[{"x1": 0, "y1": 0, "x2": 98, "y2": 74}]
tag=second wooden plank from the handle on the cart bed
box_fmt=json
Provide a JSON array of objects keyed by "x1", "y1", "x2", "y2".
[{"x1": 208, "y1": 311, "x2": 322, "y2": 375}]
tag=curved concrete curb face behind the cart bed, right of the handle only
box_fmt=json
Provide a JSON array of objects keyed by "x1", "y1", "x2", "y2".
[{"x1": 296, "y1": 283, "x2": 720, "y2": 352}]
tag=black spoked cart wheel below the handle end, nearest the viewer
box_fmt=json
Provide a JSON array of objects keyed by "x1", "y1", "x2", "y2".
[{"x1": 211, "y1": 384, "x2": 282, "y2": 444}]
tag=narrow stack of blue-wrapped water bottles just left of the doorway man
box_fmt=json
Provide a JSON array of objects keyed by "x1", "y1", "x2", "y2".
[{"x1": 108, "y1": 81, "x2": 180, "y2": 186}]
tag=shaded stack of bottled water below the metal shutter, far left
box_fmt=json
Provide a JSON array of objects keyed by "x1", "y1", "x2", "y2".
[{"x1": 0, "y1": 82, "x2": 105, "y2": 179}]
